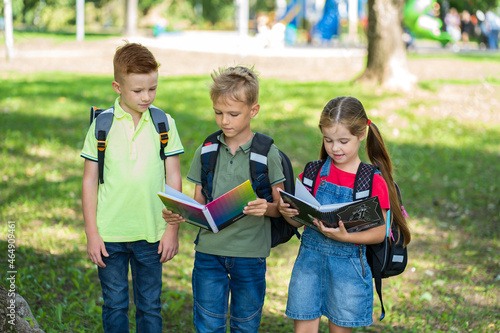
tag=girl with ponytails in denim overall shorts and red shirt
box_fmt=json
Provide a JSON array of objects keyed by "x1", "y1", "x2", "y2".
[{"x1": 279, "y1": 97, "x2": 410, "y2": 333}]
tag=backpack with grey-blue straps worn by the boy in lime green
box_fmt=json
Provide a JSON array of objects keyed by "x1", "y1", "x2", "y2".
[{"x1": 90, "y1": 105, "x2": 170, "y2": 184}]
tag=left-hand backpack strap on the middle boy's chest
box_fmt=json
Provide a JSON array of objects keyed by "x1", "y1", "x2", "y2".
[{"x1": 200, "y1": 130, "x2": 222, "y2": 202}]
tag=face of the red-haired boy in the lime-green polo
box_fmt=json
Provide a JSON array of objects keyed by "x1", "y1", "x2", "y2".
[{"x1": 113, "y1": 72, "x2": 158, "y2": 116}]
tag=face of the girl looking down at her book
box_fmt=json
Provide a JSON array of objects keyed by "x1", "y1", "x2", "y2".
[{"x1": 321, "y1": 124, "x2": 366, "y2": 170}]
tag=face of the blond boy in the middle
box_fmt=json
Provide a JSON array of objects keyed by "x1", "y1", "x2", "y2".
[{"x1": 213, "y1": 97, "x2": 260, "y2": 138}]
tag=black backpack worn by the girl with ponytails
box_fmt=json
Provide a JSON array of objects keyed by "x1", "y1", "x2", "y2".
[{"x1": 302, "y1": 160, "x2": 408, "y2": 320}]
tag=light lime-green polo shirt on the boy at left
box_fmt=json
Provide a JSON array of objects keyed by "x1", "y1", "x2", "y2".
[{"x1": 81, "y1": 98, "x2": 184, "y2": 243}]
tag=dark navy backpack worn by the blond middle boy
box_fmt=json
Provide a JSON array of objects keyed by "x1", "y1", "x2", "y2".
[{"x1": 201, "y1": 130, "x2": 300, "y2": 247}]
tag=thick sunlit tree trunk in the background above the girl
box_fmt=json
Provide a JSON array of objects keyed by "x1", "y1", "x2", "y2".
[{"x1": 357, "y1": 0, "x2": 416, "y2": 90}]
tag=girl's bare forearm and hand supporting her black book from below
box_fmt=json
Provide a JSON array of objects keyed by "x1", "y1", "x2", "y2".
[{"x1": 314, "y1": 209, "x2": 387, "y2": 244}]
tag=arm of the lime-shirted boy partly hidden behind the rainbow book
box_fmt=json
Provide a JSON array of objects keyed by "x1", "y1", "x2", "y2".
[{"x1": 158, "y1": 155, "x2": 182, "y2": 262}]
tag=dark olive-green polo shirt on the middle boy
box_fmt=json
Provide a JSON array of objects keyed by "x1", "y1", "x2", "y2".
[{"x1": 187, "y1": 135, "x2": 285, "y2": 258}]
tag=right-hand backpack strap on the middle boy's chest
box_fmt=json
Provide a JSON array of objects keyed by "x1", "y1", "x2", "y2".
[{"x1": 250, "y1": 133, "x2": 274, "y2": 202}]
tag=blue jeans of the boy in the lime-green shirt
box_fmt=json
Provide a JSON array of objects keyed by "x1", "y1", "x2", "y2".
[{"x1": 98, "y1": 241, "x2": 163, "y2": 333}]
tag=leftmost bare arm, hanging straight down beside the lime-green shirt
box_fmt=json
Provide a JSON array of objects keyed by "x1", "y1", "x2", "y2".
[{"x1": 82, "y1": 159, "x2": 108, "y2": 267}]
